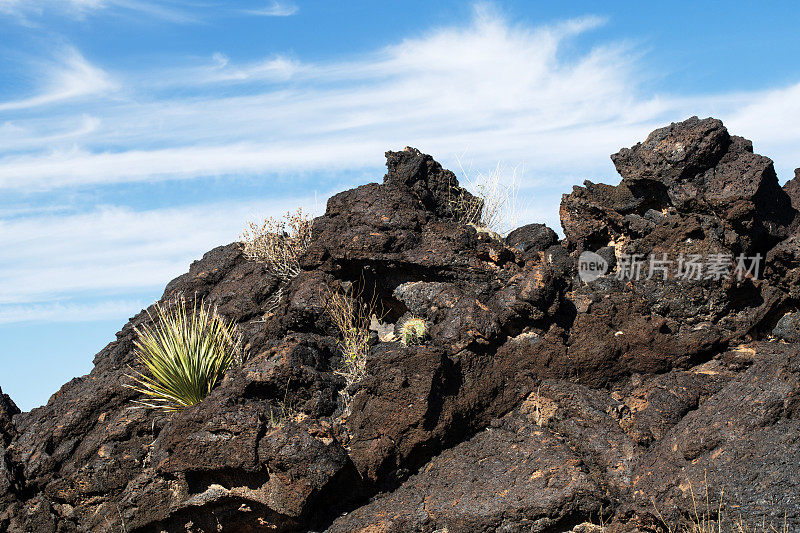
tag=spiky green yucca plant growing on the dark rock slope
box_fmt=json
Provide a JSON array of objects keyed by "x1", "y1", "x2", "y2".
[{"x1": 126, "y1": 299, "x2": 242, "y2": 411}]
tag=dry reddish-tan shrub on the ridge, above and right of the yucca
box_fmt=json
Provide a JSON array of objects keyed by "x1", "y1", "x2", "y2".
[{"x1": 239, "y1": 209, "x2": 311, "y2": 281}]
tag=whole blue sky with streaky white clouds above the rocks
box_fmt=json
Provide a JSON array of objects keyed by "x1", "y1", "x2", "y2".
[{"x1": 0, "y1": 0, "x2": 800, "y2": 409}]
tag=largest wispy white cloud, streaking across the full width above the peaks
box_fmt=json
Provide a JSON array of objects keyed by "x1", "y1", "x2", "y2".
[{"x1": 0, "y1": 7, "x2": 800, "y2": 195}]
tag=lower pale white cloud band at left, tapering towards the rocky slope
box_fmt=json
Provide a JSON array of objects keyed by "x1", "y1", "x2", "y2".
[{"x1": 0, "y1": 197, "x2": 314, "y2": 308}]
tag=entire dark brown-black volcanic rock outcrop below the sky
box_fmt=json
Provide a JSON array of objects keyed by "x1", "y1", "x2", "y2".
[{"x1": 0, "y1": 117, "x2": 800, "y2": 533}]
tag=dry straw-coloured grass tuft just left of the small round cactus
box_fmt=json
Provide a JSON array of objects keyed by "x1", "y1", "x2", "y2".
[{"x1": 325, "y1": 285, "x2": 377, "y2": 414}]
